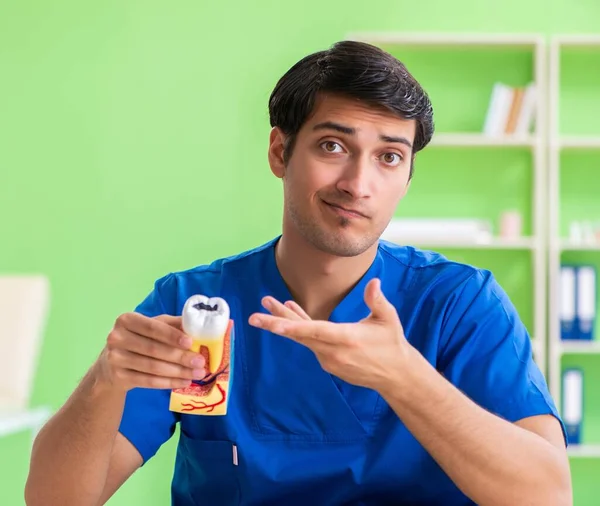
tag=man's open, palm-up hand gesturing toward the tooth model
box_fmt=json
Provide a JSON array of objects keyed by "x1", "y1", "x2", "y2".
[{"x1": 249, "y1": 279, "x2": 410, "y2": 390}]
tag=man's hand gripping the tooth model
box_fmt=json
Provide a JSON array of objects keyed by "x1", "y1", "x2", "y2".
[{"x1": 96, "y1": 313, "x2": 206, "y2": 392}]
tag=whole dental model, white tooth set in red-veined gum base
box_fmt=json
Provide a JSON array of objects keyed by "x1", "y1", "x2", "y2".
[{"x1": 169, "y1": 295, "x2": 234, "y2": 415}]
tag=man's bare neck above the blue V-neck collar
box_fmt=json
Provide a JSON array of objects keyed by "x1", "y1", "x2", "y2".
[{"x1": 275, "y1": 232, "x2": 377, "y2": 320}]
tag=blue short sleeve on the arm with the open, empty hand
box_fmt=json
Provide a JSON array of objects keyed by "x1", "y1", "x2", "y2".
[{"x1": 438, "y1": 270, "x2": 566, "y2": 442}]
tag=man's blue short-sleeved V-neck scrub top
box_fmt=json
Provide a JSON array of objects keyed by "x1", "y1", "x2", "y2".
[{"x1": 120, "y1": 237, "x2": 564, "y2": 506}]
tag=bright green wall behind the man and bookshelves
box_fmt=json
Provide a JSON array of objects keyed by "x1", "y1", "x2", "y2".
[{"x1": 0, "y1": 0, "x2": 600, "y2": 506}]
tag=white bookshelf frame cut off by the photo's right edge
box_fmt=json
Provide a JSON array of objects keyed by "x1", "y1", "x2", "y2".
[{"x1": 548, "y1": 35, "x2": 600, "y2": 458}]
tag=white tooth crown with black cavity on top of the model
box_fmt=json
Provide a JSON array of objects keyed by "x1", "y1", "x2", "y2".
[{"x1": 182, "y1": 295, "x2": 229, "y2": 340}]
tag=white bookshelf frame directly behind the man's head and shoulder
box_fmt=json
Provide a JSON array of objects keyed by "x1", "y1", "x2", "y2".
[{"x1": 347, "y1": 32, "x2": 547, "y2": 374}]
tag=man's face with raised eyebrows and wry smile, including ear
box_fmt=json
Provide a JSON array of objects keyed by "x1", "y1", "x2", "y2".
[{"x1": 269, "y1": 95, "x2": 415, "y2": 256}]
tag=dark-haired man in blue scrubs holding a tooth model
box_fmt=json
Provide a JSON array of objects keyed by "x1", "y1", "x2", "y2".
[{"x1": 26, "y1": 42, "x2": 571, "y2": 506}]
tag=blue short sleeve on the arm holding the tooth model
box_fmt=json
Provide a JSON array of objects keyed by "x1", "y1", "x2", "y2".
[{"x1": 119, "y1": 275, "x2": 179, "y2": 464}]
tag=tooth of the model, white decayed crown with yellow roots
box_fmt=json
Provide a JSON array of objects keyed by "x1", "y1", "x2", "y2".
[{"x1": 182, "y1": 295, "x2": 229, "y2": 373}]
